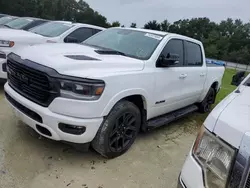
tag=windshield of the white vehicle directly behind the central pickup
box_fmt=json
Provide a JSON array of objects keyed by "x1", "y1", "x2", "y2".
[{"x1": 29, "y1": 22, "x2": 73, "y2": 37}]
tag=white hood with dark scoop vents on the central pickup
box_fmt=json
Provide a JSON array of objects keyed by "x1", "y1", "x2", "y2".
[{"x1": 16, "y1": 44, "x2": 144, "y2": 78}]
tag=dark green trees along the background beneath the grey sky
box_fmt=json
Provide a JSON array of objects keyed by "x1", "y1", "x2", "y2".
[{"x1": 0, "y1": 0, "x2": 250, "y2": 64}]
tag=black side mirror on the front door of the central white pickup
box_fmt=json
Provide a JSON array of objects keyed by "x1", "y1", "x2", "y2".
[{"x1": 157, "y1": 53, "x2": 180, "y2": 67}]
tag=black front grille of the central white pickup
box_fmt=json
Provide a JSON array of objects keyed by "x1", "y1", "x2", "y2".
[{"x1": 7, "y1": 58, "x2": 58, "y2": 106}]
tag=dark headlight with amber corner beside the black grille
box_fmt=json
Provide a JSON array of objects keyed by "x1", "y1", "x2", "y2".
[{"x1": 59, "y1": 80, "x2": 105, "y2": 100}]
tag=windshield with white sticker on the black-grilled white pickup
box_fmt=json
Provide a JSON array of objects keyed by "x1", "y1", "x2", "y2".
[{"x1": 83, "y1": 28, "x2": 163, "y2": 60}]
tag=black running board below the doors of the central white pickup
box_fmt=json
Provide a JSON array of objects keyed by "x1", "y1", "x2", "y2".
[{"x1": 147, "y1": 105, "x2": 198, "y2": 130}]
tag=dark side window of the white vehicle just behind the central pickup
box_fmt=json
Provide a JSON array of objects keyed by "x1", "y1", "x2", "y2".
[{"x1": 67, "y1": 28, "x2": 93, "y2": 43}]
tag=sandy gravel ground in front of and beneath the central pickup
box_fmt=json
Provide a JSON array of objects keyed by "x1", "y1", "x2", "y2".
[{"x1": 0, "y1": 86, "x2": 197, "y2": 188}]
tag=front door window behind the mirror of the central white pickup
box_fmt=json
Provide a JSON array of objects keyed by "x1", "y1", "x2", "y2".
[{"x1": 161, "y1": 39, "x2": 184, "y2": 67}]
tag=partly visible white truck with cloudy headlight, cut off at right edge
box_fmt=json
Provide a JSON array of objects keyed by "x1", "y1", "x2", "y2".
[{"x1": 178, "y1": 71, "x2": 250, "y2": 188}]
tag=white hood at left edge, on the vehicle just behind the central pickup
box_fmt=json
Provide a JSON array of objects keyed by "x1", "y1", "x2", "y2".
[{"x1": 0, "y1": 28, "x2": 48, "y2": 43}]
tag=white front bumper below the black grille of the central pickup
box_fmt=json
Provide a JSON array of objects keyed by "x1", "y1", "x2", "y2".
[{"x1": 4, "y1": 83, "x2": 103, "y2": 144}]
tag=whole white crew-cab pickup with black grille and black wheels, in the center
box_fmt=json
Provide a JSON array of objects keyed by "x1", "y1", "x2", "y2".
[{"x1": 4, "y1": 28, "x2": 224, "y2": 158}]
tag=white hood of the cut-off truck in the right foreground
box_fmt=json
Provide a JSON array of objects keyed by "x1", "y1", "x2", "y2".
[{"x1": 204, "y1": 85, "x2": 250, "y2": 148}]
